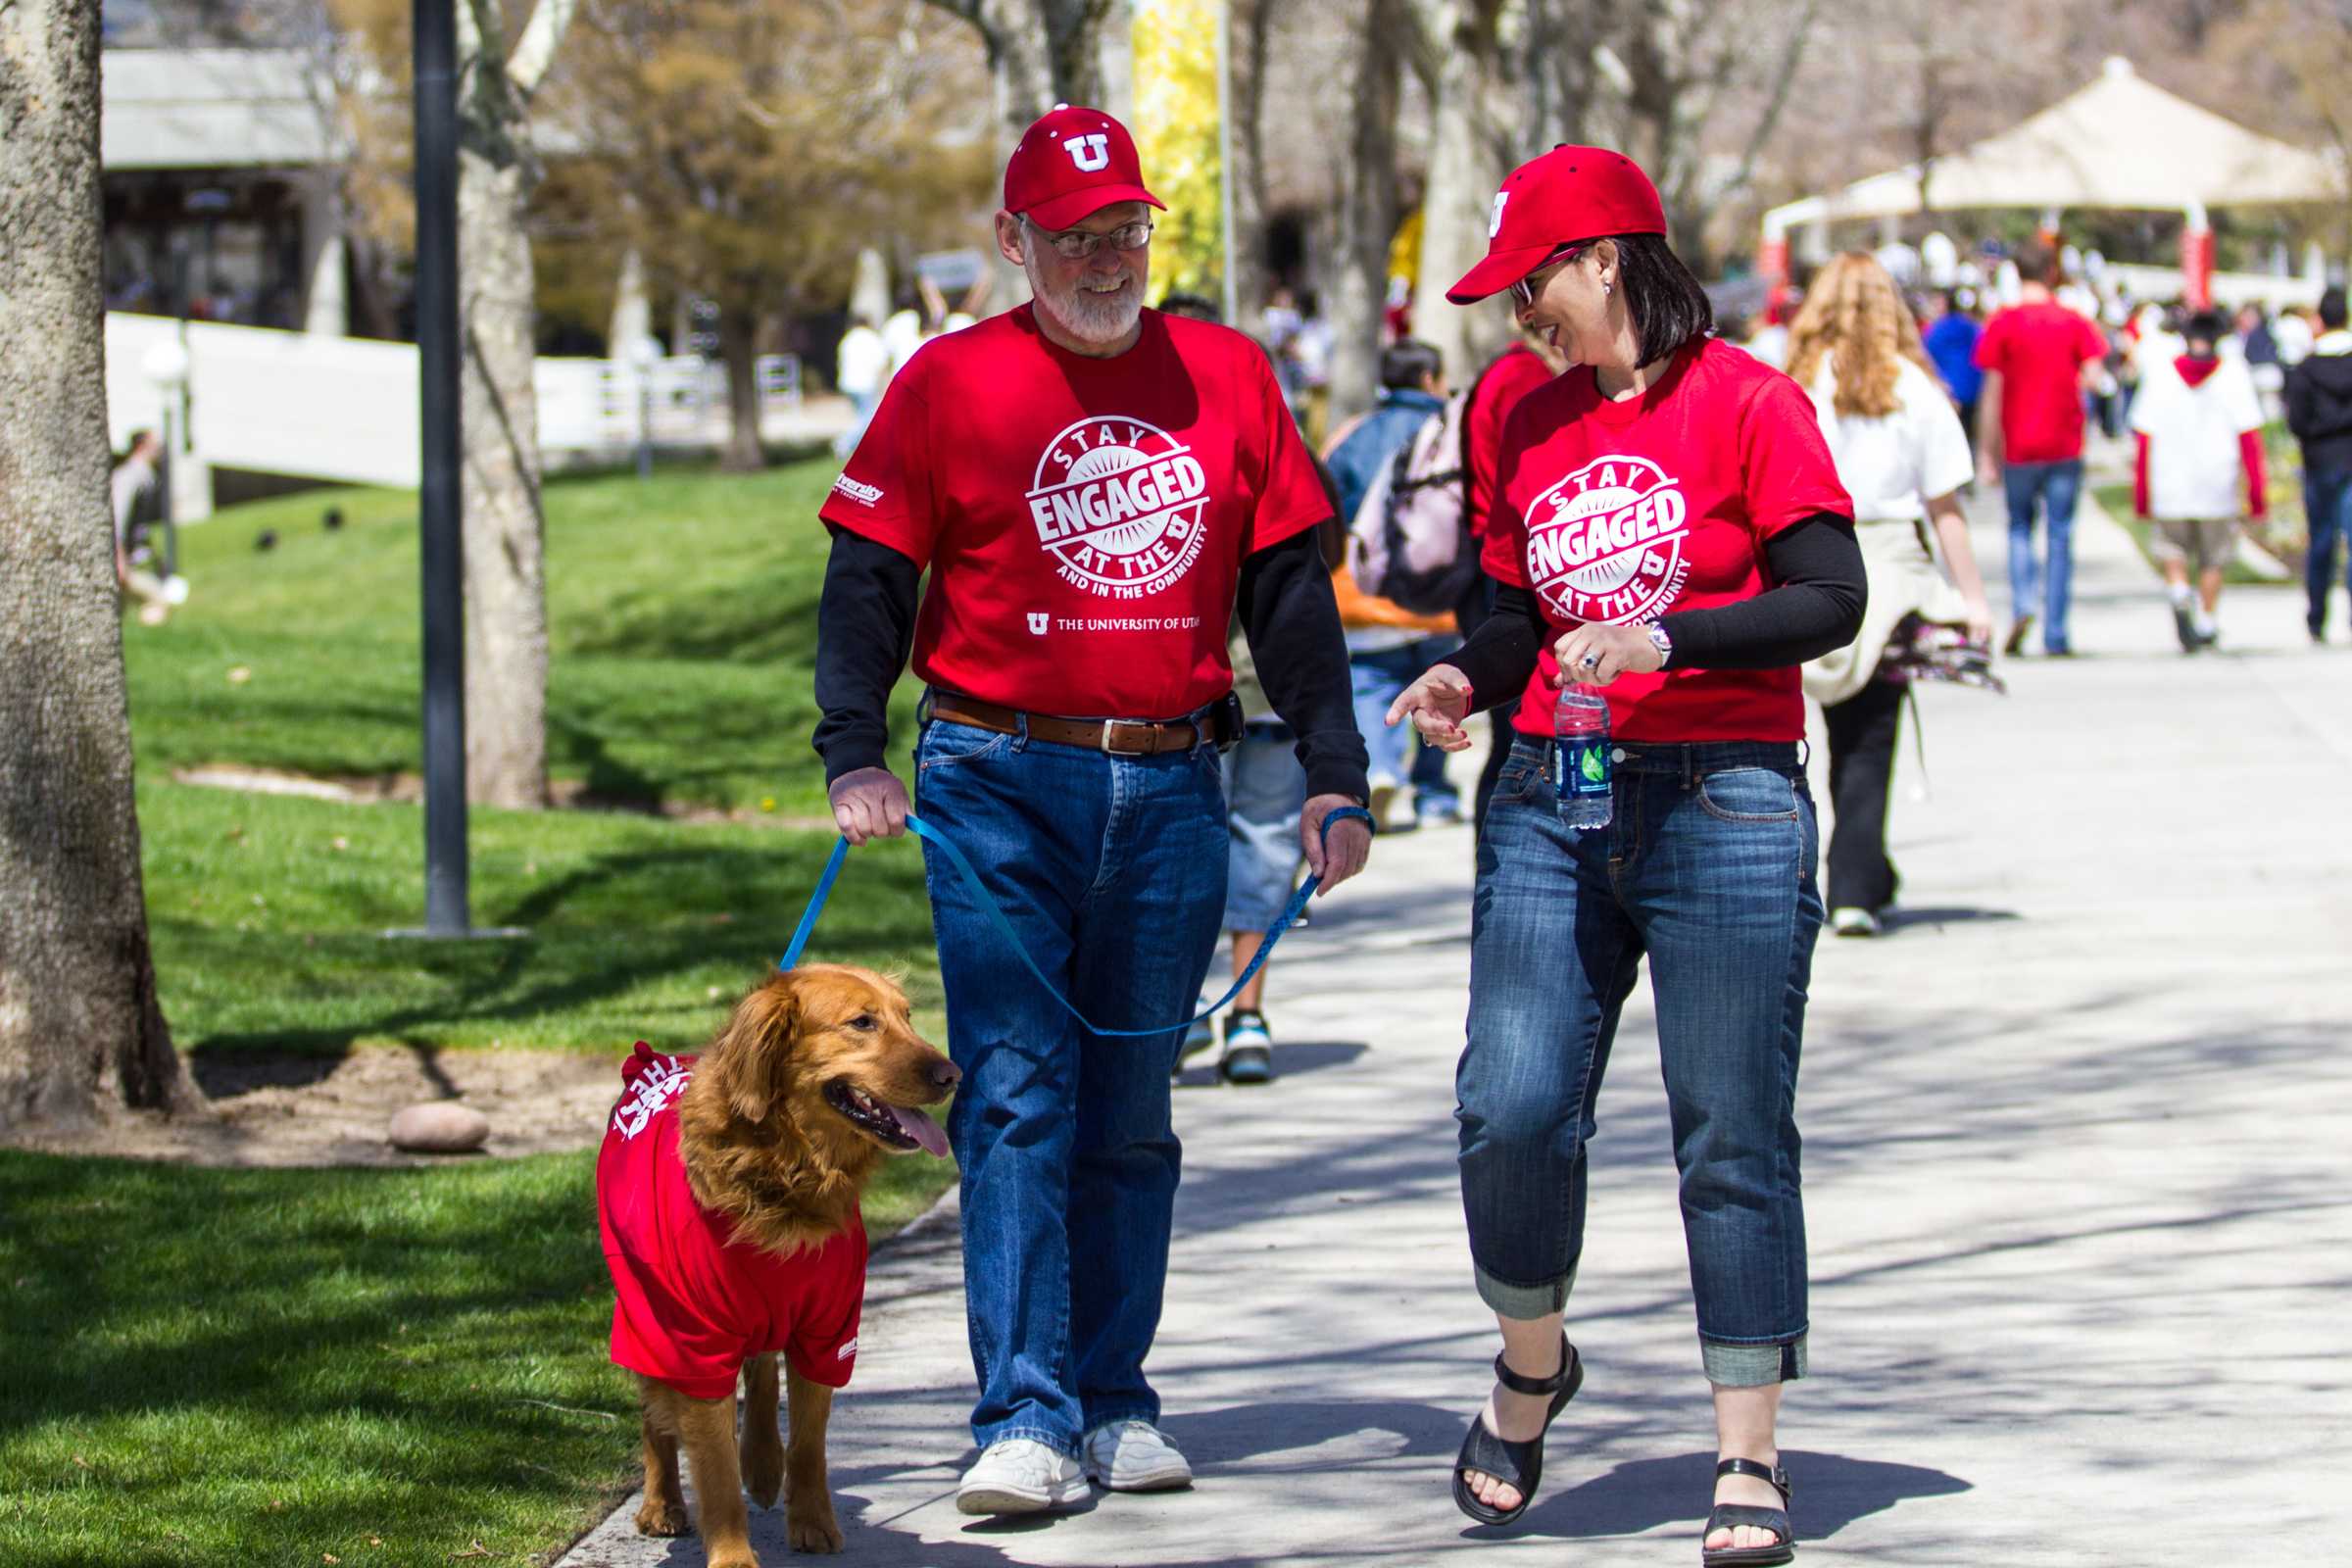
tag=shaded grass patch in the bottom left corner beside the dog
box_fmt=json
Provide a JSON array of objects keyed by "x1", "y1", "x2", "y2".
[{"x1": 0, "y1": 1152, "x2": 635, "y2": 1568}]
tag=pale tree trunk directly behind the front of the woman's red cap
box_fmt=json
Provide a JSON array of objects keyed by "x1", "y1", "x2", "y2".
[{"x1": 1411, "y1": 0, "x2": 1512, "y2": 385}]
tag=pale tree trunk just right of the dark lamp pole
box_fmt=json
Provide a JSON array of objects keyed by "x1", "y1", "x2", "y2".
[{"x1": 457, "y1": 0, "x2": 560, "y2": 808}]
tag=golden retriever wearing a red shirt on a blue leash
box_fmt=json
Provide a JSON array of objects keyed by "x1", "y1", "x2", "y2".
[{"x1": 598, "y1": 964, "x2": 962, "y2": 1568}]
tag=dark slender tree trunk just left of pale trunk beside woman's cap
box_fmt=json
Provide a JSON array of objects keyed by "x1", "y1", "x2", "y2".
[{"x1": 1329, "y1": 0, "x2": 1404, "y2": 425}]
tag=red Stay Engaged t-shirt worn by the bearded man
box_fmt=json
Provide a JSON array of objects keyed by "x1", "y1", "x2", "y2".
[{"x1": 818, "y1": 306, "x2": 1331, "y2": 719}]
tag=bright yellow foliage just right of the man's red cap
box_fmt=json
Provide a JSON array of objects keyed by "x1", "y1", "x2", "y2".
[{"x1": 1131, "y1": 0, "x2": 1225, "y2": 299}]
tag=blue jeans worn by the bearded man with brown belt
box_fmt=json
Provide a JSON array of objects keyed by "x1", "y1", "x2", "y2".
[{"x1": 915, "y1": 721, "x2": 1225, "y2": 1457}]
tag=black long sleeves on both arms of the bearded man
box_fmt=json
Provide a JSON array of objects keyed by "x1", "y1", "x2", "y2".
[{"x1": 811, "y1": 529, "x2": 1371, "y2": 800}]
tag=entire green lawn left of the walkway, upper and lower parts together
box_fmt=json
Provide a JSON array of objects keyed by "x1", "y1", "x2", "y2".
[{"x1": 0, "y1": 464, "x2": 953, "y2": 1568}]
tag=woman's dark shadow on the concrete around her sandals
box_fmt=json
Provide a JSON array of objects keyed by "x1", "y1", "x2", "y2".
[{"x1": 1505, "y1": 1448, "x2": 1971, "y2": 1540}]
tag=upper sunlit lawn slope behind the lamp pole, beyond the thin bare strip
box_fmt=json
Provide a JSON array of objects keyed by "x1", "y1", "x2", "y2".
[{"x1": 124, "y1": 461, "x2": 912, "y2": 815}]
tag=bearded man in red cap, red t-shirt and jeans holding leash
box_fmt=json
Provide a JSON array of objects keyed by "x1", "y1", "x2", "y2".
[{"x1": 816, "y1": 104, "x2": 1371, "y2": 1514}]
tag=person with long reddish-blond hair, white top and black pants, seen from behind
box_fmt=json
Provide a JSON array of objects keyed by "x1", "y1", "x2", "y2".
[{"x1": 1788, "y1": 252, "x2": 1992, "y2": 936}]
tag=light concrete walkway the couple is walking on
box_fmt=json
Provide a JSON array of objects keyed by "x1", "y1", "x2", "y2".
[{"x1": 564, "y1": 493, "x2": 2352, "y2": 1568}]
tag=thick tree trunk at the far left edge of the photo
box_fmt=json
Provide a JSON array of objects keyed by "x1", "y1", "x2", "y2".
[{"x1": 0, "y1": 0, "x2": 185, "y2": 1126}]
